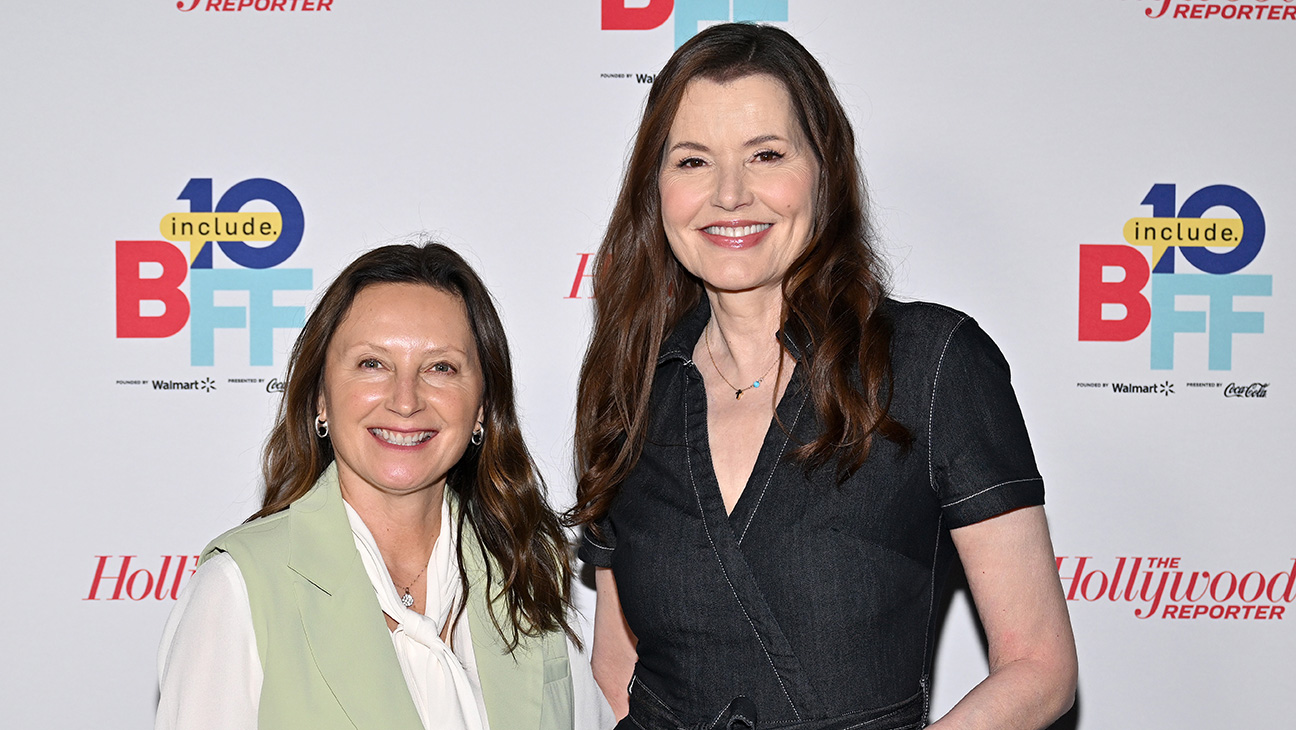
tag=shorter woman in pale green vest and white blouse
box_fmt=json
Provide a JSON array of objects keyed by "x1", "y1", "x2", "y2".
[{"x1": 157, "y1": 244, "x2": 607, "y2": 730}]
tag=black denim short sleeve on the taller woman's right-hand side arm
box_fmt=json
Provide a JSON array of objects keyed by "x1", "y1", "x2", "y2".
[{"x1": 928, "y1": 318, "x2": 1045, "y2": 529}]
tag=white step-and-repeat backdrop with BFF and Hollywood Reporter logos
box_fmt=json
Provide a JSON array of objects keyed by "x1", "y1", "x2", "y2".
[{"x1": 0, "y1": 0, "x2": 1296, "y2": 730}]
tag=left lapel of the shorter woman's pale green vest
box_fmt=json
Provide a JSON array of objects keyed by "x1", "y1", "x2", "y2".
[{"x1": 288, "y1": 464, "x2": 422, "y2": 730}]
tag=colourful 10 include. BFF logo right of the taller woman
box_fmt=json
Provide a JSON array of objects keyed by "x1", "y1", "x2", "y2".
[{"x1": 1080, "y1": 184, "x2": 1274, "y2": 370}]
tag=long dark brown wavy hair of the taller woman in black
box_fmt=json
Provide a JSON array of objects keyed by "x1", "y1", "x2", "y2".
[{"x1": 568, "y1": 23, "x2": 912, "y2": 524}]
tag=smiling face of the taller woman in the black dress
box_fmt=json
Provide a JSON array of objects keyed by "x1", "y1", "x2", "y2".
[{"x1": 660, "y1": 75, "x2": 819, "y2": 292}]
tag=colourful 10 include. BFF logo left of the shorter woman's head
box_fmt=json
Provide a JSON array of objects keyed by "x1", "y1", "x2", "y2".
[{"x1": 117, "y1": 178, "x2": 312, "y2": 366}]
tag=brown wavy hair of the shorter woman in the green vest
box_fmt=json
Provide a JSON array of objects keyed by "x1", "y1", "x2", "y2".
[{"x1": 249, "y1": 242, "x2": 577, "y2": 651}]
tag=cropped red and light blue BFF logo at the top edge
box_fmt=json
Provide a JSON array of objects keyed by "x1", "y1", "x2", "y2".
[{"x1": 603, "y1": 0, "x2": 788, "y2": 48}]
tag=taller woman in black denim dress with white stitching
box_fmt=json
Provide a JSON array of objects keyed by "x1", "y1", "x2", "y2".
[{"x1": 572, "y1": 23, "x2": 1076, "y2": 730}]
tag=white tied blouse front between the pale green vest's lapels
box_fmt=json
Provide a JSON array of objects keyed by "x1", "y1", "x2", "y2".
[{"x1": 346, "y1": 500, "x2": 486, "y2": 730}]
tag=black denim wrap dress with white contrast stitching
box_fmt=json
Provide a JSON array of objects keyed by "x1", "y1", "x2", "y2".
[{"x1": 581, "y1": 301, "x2": 1043, "y2": 730}]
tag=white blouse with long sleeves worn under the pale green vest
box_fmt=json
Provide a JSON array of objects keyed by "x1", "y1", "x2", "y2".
[{"x1": 154, "y1": 503, "x2": 616, "y2": 730}]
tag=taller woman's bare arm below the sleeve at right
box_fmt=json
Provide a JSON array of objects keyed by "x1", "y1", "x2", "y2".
[{"x1": 931, "y1": 507, "x2": 1077, "y2": 730}]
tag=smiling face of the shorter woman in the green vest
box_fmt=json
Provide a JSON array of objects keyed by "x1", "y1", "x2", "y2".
[{"x1": 319, "y1": 284, "x2": 483, "y2": 494}]
